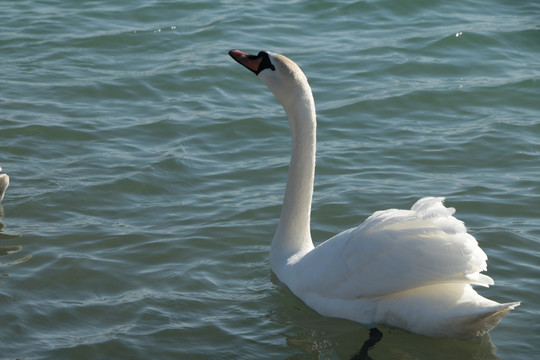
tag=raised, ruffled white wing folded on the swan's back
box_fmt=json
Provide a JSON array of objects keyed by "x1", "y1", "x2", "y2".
[{"x1": 297, "y1": 198, "x2": 493, "y2": 299}]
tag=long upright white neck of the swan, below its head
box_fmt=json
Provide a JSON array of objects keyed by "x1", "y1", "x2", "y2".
[{"x1": 270, "y1": 86, "x2": 317, "y2": 268}]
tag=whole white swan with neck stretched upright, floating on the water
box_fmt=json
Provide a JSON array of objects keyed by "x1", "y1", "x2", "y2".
[{"x1": 229, "y1": 50, "x2": 520, "y2": 338}]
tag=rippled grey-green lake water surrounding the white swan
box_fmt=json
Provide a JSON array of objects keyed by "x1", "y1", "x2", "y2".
[{"x1": 0, "y1": 0, "x2": 540, "y2": 360}]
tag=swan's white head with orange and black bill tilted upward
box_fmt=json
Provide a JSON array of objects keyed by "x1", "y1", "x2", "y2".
[{"x1": 229, "y1": 50, "x2": 311, "y2": 106}]
